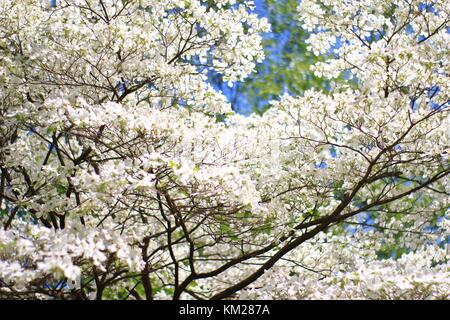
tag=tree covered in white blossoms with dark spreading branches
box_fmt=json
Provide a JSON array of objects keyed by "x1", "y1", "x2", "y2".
[{"x1": 0, "y1": 0, "x2": 450, "y2": 299}]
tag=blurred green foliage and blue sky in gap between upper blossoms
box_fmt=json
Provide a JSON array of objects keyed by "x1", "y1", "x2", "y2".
[{"x1": 210, "y1": 0, "x2": 328, "y2": 114}]
